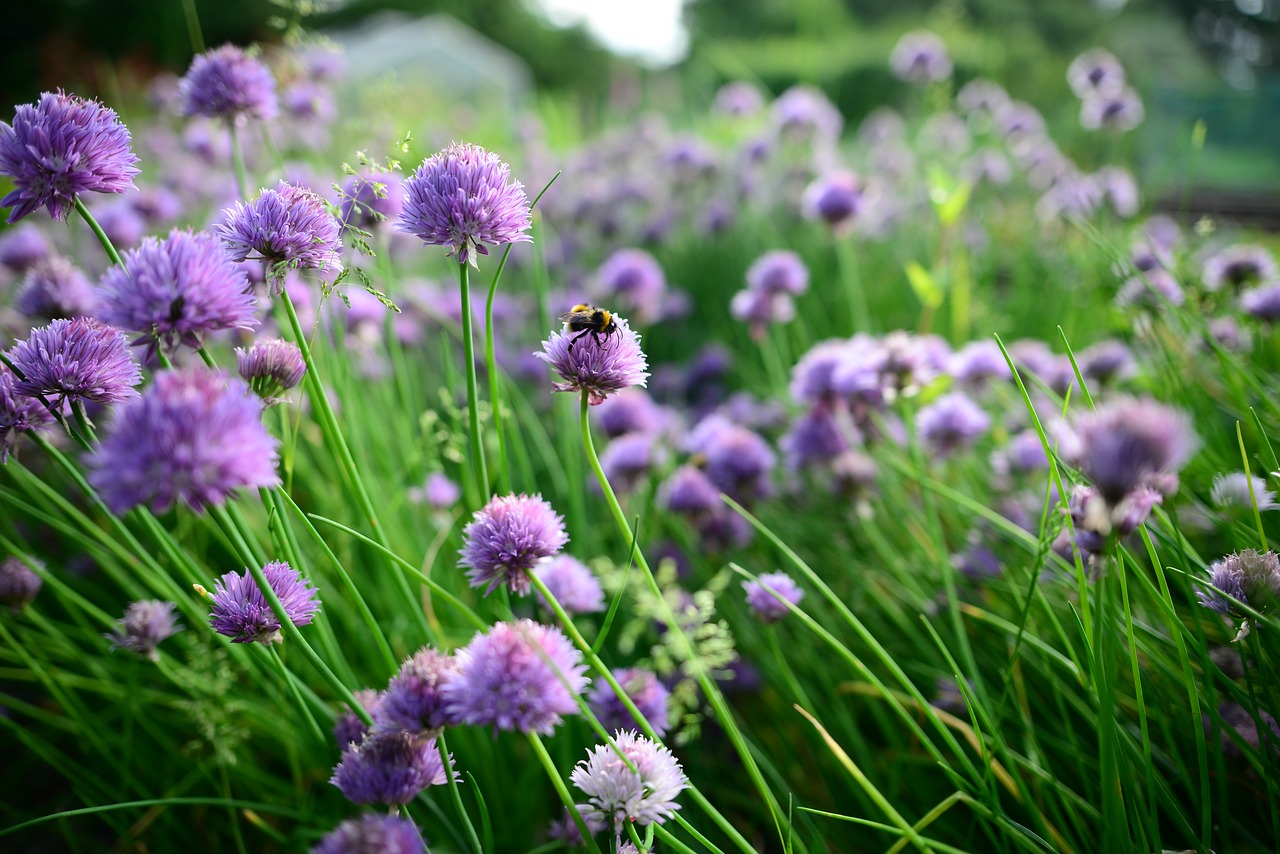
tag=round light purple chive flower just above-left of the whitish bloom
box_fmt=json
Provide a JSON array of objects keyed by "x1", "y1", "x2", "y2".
[{"x1": 440, "y1": 620, "x2": 590, "y2": 735}]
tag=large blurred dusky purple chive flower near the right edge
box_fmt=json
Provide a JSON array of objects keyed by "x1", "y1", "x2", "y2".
[{"x1": 1076, "y1": 397, "x2": 1197, "y2": 507}]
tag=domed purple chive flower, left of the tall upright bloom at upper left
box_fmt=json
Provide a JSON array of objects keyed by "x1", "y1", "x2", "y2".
[{"x1": 215, "y1": 181, "x2": 342, "y2": 285}]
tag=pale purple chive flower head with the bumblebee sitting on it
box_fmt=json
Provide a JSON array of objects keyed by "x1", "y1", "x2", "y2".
[{"x1": 534, "y1": 315, "x2": 649, "y2": 406}]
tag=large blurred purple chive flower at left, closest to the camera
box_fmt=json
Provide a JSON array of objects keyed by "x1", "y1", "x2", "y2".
[{"x1": 88, "y1": 367, "x2": 280, "y2": 513}]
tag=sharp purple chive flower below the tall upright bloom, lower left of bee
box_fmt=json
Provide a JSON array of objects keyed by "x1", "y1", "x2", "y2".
[{"x1": 458, "y1": 495, "x2": 568, "y2": 595}]
